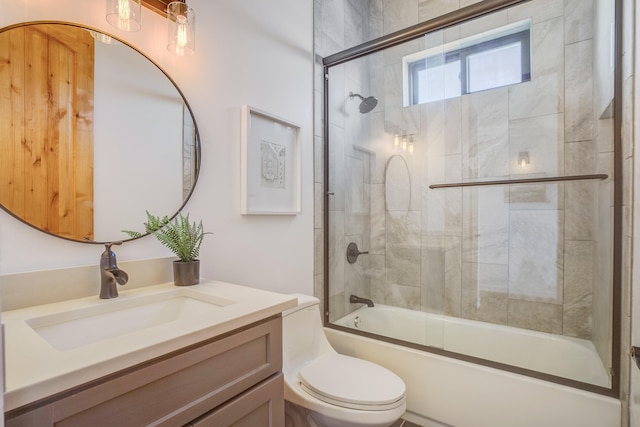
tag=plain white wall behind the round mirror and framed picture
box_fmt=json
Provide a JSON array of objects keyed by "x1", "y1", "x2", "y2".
[{"x1": 0, "y1": 0, "x2": 313, "y2": 293}]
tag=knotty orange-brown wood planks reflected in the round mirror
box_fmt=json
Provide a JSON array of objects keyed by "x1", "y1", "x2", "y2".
[{"x1": 0, "y1": 25, "x2": 94, "y2": 240}]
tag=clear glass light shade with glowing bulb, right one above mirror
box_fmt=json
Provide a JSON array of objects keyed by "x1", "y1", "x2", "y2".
[{"x1": 167, "y1": 1, "x2": 196, "y2": 56}]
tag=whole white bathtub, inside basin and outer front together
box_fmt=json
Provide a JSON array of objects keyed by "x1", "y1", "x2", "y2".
[{"x1": 325, "y1": 305, "x2": 621, "y2": 427}]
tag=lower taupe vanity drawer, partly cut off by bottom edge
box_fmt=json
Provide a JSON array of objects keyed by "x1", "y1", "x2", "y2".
[{"x1": 189, "y1": 374, "x2": 284, "y2": 427}]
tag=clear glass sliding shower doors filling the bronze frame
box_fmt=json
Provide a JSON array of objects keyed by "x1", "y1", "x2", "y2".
[{"x1": 324, "y1": 0, "x2": 620, "y2": 394}]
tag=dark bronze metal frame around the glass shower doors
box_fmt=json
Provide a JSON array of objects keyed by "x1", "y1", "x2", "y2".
[{"x1": 323, "y1": 0, "x2": 623, "y2": 398}]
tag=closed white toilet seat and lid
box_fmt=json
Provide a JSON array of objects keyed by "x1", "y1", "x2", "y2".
[{"x1": 299, "y1": 353, "x2": 405, "y2": 411}]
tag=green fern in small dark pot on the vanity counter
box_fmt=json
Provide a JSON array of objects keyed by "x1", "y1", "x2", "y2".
[{"x1": 123, "y1": 211, "x2": 211, "y2": 286}]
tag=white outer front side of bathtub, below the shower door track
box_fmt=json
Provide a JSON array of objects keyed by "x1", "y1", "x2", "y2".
[{"x1": 325, "y1": 328, "x2": 621, "y2": 427}]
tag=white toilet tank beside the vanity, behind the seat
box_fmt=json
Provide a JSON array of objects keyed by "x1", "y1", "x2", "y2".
[{"x1": 282, "y1": 295, "x2": 335, "y2": 375}]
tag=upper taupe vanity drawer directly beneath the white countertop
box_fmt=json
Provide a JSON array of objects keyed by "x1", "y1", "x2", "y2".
[{"x1": 7, "y1": 317, "x2": 282, "y2": 427}]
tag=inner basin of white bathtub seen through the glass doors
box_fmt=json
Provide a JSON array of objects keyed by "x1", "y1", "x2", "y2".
[{"x1": 334, "y1": 305, "x2": 610, "y2": 387}]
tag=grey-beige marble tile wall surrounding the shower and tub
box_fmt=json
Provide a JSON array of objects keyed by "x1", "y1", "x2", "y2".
[{"x1": 315, "y1": 0, "x2": 613, "y2": 344}]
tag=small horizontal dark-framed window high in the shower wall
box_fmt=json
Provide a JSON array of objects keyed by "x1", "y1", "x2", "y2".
[{"x1": 403, "y1": 20, "x2": 531, "y2": 106}]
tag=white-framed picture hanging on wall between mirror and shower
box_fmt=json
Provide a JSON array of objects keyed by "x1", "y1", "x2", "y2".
[{"x1": 240, "y1": 105, "x2": 300, "y2": 215}]
